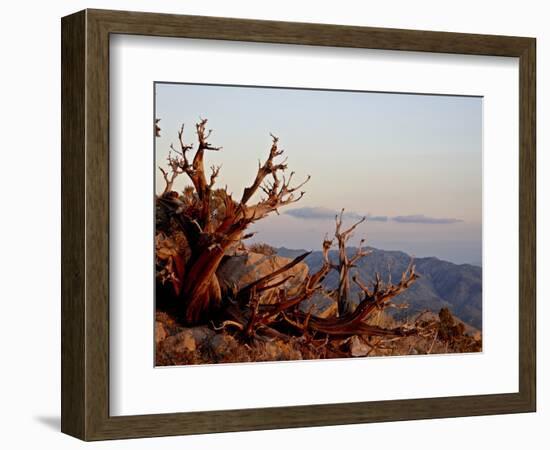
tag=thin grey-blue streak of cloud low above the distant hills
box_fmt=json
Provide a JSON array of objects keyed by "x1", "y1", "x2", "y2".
[{"x1": 285, "y1": 207, "x2": 462, "y2": 225}]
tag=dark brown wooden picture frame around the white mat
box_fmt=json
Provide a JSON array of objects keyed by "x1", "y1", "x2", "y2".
[{"x1": 61, "y1": 10, "x2": 536, "y2": 440}]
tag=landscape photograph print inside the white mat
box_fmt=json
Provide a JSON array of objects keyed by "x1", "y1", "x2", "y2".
[{"x1": 152, "y1": 82, "x2": 483, "y2": 366}]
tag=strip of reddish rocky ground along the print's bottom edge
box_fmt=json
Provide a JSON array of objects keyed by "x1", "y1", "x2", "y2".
[{"x1": 155, "y1": 312, "x2": 481, "y2": 366}]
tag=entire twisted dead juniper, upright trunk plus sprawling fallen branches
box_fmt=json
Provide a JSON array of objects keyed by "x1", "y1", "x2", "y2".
[{"x1": 156, "y1": 120, "x2": 417, "y2": 348}]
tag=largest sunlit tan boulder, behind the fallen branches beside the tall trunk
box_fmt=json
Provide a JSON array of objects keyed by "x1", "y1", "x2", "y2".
[{"x1": 216, "y1": 252, "x2": 309, "y2": 303}]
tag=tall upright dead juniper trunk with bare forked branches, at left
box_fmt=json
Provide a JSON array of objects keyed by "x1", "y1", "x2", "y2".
[{"x1": 157, "y1": 119, "x2": 309, "y2": 324}]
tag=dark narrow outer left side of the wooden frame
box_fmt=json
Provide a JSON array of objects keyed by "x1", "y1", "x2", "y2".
[{"x1": 61, "y1": 12, "x2": 86, "y2": 438}]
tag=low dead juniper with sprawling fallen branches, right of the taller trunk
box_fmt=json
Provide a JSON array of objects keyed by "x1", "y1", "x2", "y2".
[{"x1": 232, "y1": 210, "x2": 418, "y2": 339}]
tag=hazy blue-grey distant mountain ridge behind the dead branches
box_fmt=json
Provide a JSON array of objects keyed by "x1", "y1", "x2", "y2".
[{"x1": 277, "y1": 247, "x2": 482, "y2": 330}]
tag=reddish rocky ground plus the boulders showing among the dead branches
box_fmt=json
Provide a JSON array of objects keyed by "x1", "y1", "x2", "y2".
[{"x1": 155, "y1": 251, "x2": 481, "y2": 366}]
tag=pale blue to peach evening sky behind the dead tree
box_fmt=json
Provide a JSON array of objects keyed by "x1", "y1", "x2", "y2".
[{"x1": 154, "y1": 83, "x2": 483, "y2": 265}]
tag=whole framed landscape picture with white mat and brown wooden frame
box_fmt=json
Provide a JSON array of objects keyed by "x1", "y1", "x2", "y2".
[{"x1": 62, "y1": 10, "x2": 536, "y2": 440}]
